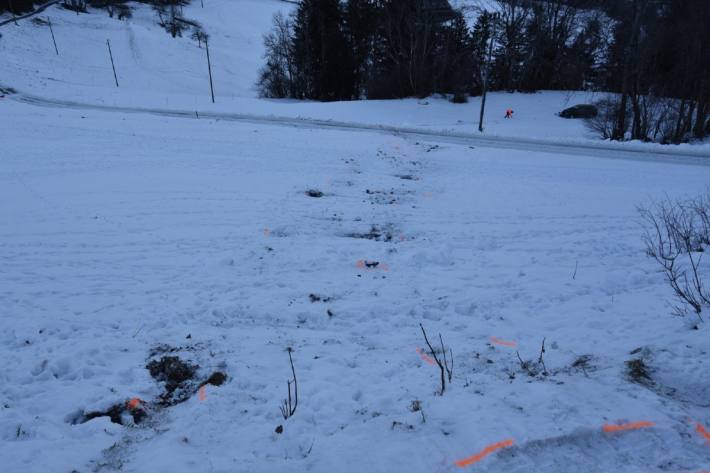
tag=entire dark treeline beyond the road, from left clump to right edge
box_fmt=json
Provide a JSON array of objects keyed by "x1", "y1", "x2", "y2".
[{"x1": 259, "y1": 0, "x2": 710, "y2": 143}]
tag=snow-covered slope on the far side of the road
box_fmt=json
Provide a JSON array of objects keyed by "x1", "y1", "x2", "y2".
[{"x1": 0, "y1": 0, "x2": 708, "y2": 149}]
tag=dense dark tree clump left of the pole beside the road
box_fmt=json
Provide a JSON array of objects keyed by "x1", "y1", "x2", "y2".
[{"x1": 261, "y1": 0, "x2": 477, "y2": 100}]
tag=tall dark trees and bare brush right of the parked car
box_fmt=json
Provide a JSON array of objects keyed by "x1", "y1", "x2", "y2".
[{"x1": 596, "y1": 0, "x2": 710, "y2": 143}]
